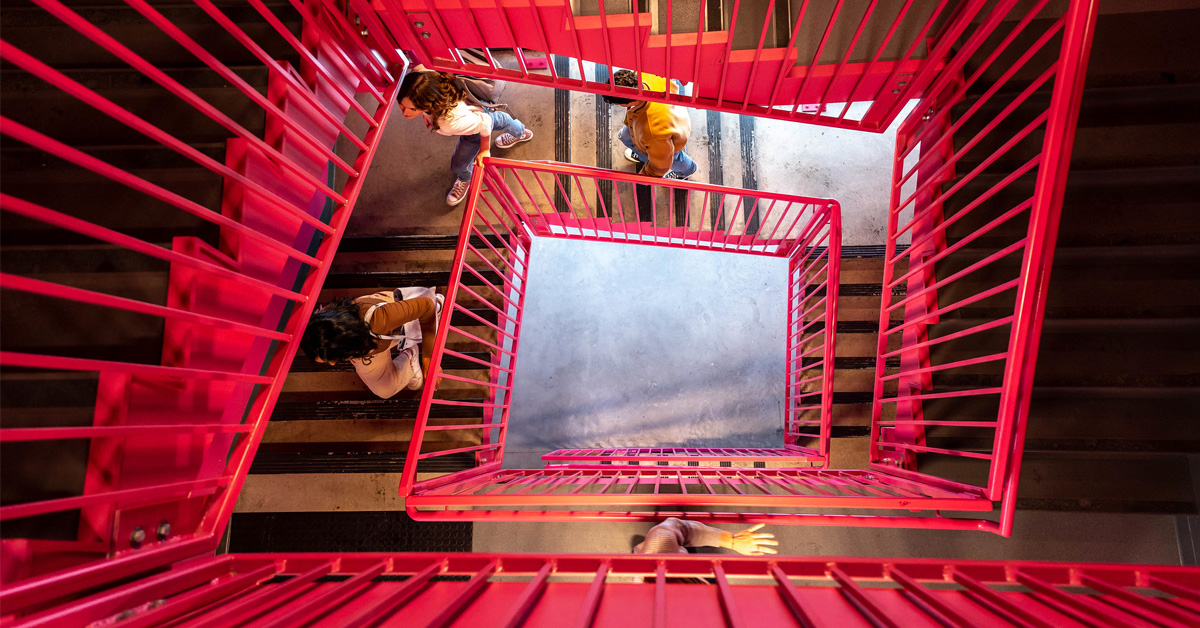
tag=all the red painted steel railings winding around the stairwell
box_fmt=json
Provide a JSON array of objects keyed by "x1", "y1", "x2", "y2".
[{"x1": 0, "y1": 0, "x2": 1104, "y2": 626}]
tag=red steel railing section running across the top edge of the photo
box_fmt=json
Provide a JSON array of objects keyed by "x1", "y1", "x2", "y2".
[{"x1": 378, "y1": 0, "x2": 988, "y2": 132}]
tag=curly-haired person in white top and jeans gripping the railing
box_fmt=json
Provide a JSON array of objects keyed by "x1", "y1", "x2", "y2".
[{"x1": 397, "y1": 72, "x2": 533, "y2": 205}]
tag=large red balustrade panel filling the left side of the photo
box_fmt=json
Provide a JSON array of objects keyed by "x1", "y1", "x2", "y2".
[{"x1": 0, "y1": 0, "x2": 403, "y2": 612}]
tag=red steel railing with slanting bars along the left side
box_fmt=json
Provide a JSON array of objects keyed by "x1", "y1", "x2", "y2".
[{"x1": 0, "y1": 0, "x2": 402, "y2": 623}]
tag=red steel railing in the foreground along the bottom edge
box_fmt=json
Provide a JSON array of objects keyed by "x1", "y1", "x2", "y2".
[{"x1": 9, "y1": 554, "x2": 1200, "y2": 628}]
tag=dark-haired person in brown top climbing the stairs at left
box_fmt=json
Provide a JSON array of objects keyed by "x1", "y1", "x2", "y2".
[{"x1": 300, "y1": 288, "x2": 443, "y2": 399}]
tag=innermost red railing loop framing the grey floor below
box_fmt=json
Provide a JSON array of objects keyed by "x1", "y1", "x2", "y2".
[{"x1": 401, "y1": 159, "x2": 1032, "y2": 528}]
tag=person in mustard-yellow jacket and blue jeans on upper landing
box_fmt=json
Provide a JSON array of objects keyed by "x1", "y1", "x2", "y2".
[{"x1": 605, "y1": 70, "x2": 696, "y2": 179}]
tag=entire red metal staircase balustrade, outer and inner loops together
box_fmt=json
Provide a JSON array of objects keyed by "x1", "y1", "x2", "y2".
[{"x1": 0, "y1": 0, "x2": 1200, "y2": 626}]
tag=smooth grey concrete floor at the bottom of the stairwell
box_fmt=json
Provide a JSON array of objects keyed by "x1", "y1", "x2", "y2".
[{"x1": 505, "y1": 238, "x2": 787, "y2": 466}]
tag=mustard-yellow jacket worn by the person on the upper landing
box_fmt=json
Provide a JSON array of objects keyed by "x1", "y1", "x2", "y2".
[{"x1": 625, "y1": 72, "x2": 691, "y2": 177}]
